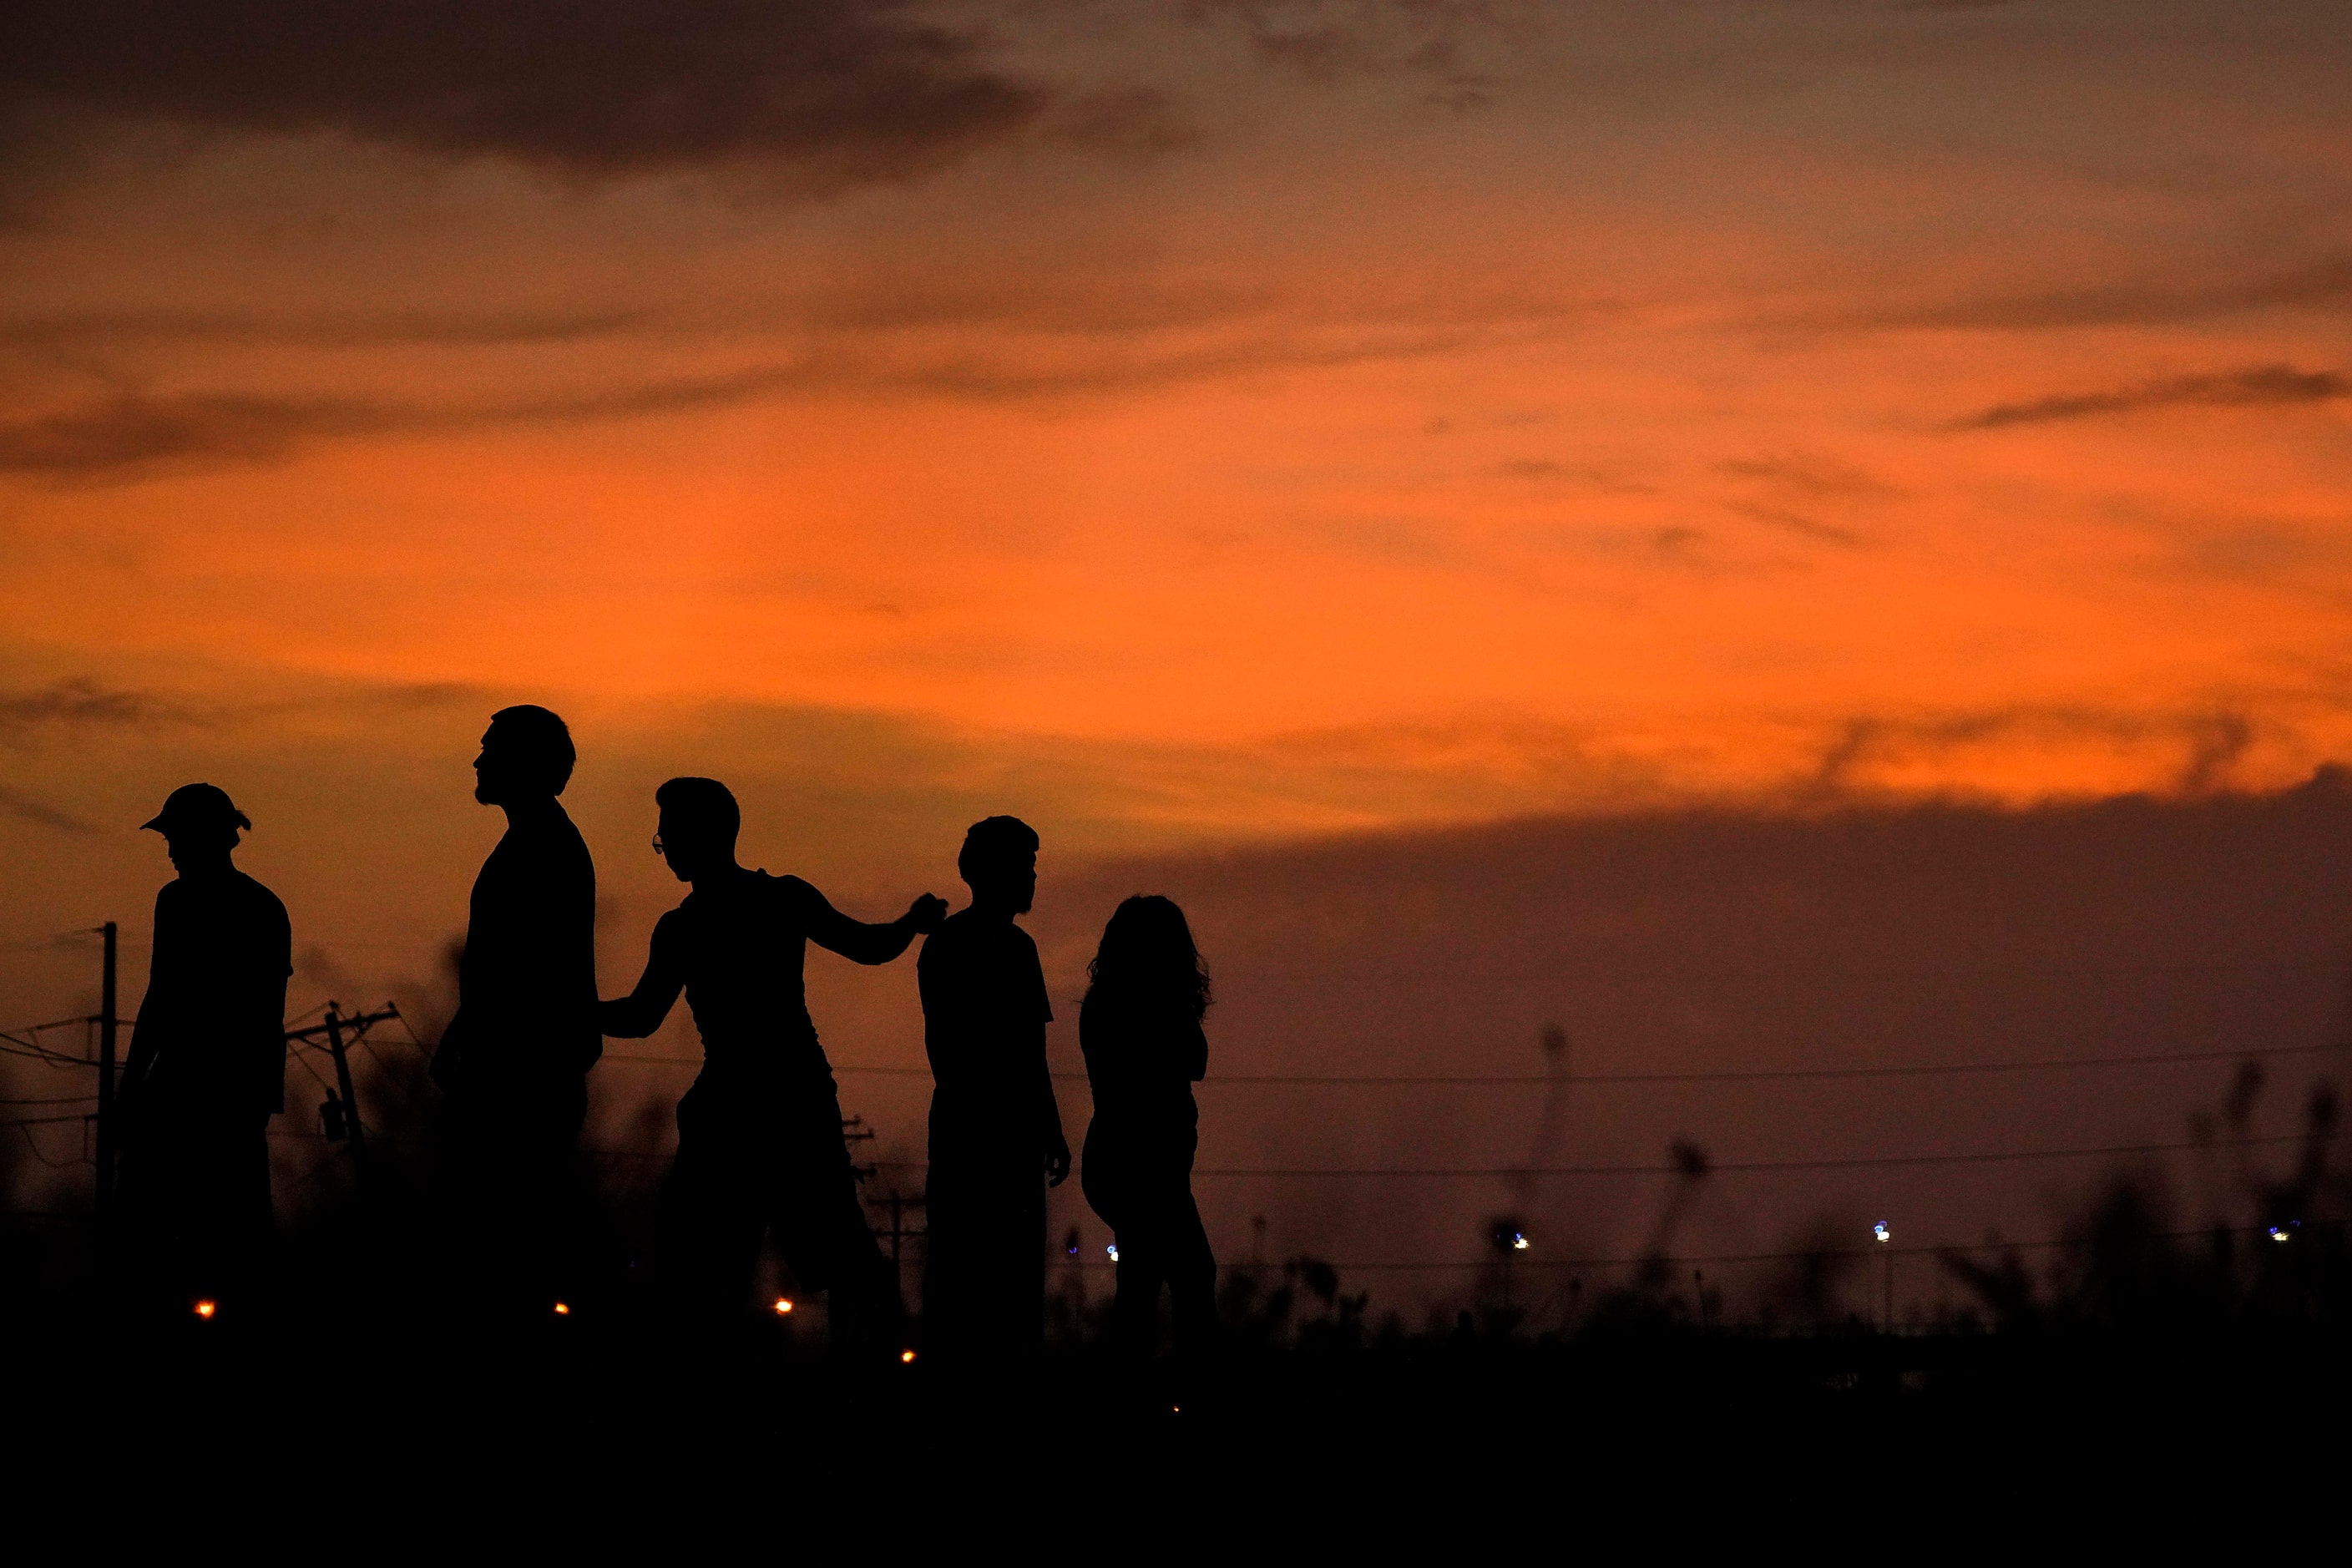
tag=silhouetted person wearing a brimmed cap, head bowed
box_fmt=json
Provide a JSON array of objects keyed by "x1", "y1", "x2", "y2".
[{"x1": 118, "y1": 785, "x2": 294, "y2": 1312}]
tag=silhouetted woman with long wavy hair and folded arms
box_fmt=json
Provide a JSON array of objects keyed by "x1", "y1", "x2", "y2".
[{"x1": 1077, "y1": 898, "x2": 1216, "y2": 1357}]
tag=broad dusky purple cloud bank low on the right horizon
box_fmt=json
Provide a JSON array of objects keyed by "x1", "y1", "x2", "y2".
[{"x1": 1063, "y1": 773, "x2": 2352, "y2": 1283}]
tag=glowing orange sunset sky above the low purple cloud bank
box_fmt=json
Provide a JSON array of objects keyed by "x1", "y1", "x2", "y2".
[{"x1": 0, "y1": 0, "x2": 2352, "y2": 1297}]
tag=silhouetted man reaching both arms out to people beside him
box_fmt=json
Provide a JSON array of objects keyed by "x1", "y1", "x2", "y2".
[{"x1": 602, "y1": 778, "x2": 948, "y2": 1352}]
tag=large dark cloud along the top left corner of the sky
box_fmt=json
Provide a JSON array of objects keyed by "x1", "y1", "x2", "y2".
[{"x1": 0, "y1": 0, "x2": 1049, "y2": 184}]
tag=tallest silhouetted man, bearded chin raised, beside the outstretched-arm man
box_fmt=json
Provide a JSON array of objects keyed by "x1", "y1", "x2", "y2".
[{"x1": 432, "y1": 706, "x2": 604, "y2": 1314}]
